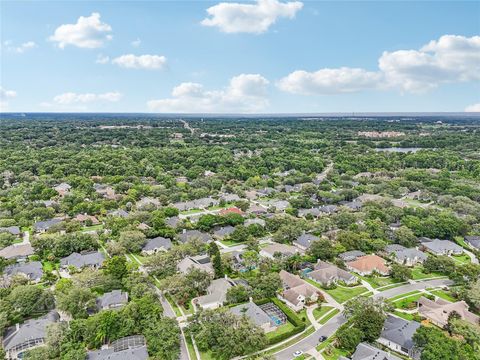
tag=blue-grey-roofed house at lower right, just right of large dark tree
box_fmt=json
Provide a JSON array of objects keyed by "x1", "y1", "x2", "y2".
[{"x1": 377, "y1": 315, "x2": 421, "y2": 359}]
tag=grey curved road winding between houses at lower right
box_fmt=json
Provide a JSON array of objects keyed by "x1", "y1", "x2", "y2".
[{"x1": 274, "y1": 279, "x2": 452, "y2": 360}]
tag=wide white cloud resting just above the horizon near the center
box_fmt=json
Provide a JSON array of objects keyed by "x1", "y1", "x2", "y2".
[{"x1": 147, "y1": 74, "x2": 269, "y2": 113}]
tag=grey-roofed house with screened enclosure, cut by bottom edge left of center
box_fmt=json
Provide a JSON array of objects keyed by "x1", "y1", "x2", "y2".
[{"x1": 86, "y1": 335, "x2": 149, "y2": 360}]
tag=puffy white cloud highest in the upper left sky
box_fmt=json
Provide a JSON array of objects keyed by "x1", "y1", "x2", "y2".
[{"x1": 49, "y1": 13, "x2": 112, "y2": 49}]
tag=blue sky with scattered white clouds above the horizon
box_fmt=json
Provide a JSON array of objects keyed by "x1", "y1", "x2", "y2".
[{"x1": 0, "y1": 0, "x2": 480, "y2": 113}]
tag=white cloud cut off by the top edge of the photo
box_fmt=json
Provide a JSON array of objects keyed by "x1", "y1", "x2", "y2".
[{"x1": 201, "y1": 0, "x2": 303, "y2": 34}]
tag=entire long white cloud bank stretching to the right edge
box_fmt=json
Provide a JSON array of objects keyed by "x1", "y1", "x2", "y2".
[{"x1": 277, "y1": 35, "x2": 480, "y2": 94}]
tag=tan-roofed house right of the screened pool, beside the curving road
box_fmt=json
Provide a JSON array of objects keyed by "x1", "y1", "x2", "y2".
[{"x1": 278, "y1": 270, "x2": 320, "y2": 311}]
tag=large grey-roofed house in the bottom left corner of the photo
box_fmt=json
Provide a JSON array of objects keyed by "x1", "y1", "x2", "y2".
[{"x1": 3, "y1": 311, "x2": 60, "y2": 360}]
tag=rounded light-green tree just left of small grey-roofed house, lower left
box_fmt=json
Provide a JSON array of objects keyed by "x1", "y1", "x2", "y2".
[{"x1": 57, "y1": 286, "x2": 96, "y2": 319}]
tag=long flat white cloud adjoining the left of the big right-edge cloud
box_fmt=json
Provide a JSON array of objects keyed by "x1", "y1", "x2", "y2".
[{"x1": 277, "y1": 67, "x2": 382, "y2": 95}]
